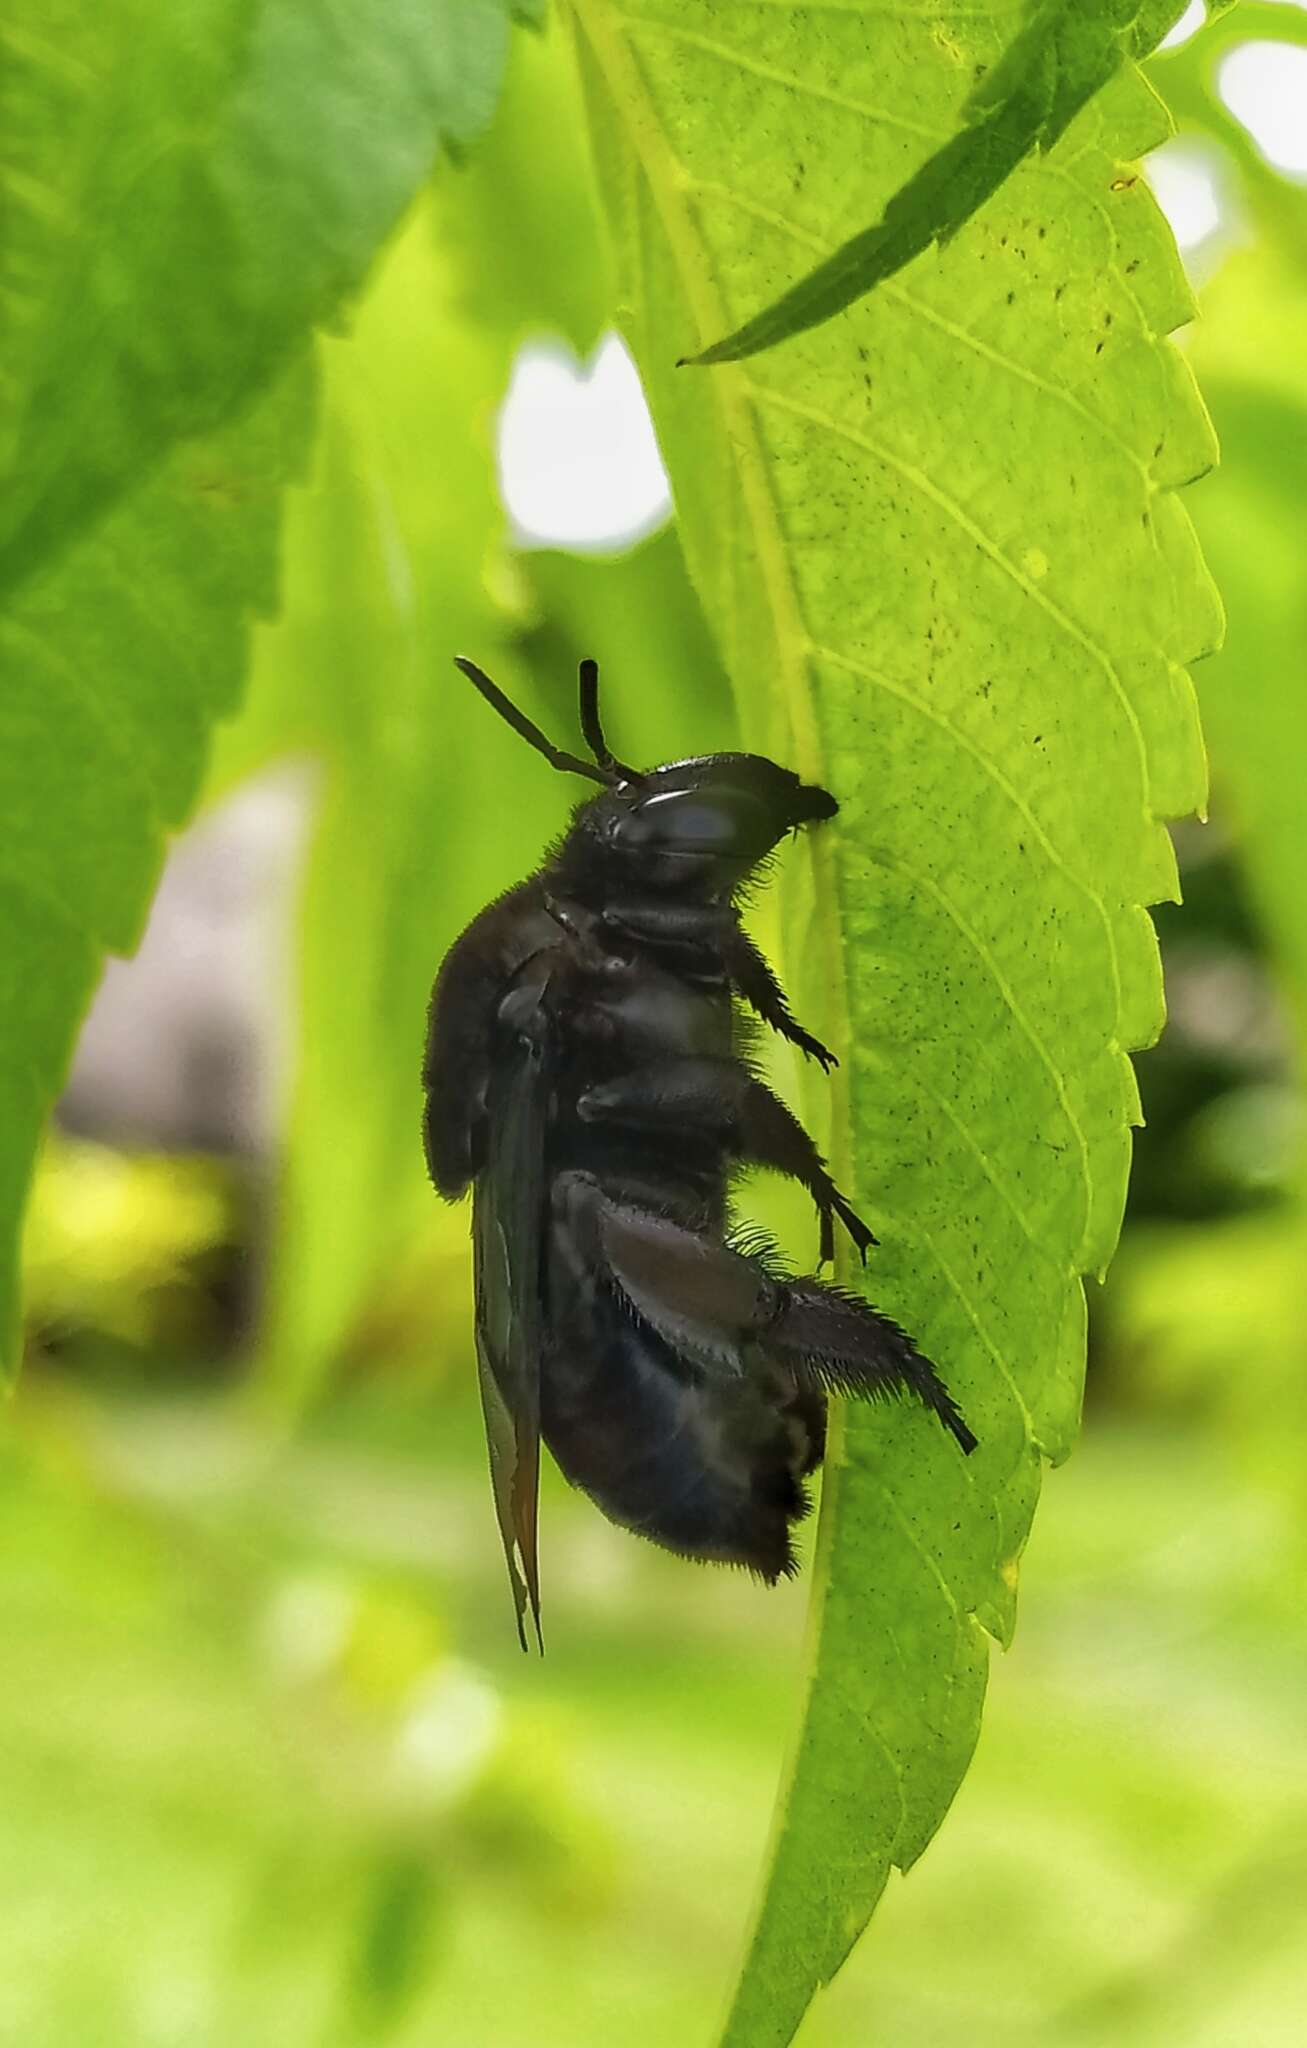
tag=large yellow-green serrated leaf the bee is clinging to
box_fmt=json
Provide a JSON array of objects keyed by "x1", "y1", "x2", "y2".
[{"x1": 567, "y1": 0, "x2": 1219, "y2": 2048}]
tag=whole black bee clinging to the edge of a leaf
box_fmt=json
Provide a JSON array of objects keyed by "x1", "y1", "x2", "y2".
[{"x1": 422, "y1": 659, "x2": 975, "y2": 1649}]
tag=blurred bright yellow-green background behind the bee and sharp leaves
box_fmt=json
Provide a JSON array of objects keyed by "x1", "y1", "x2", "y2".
[{"x1": 0, "y1": 4, "x2": 1307, "y2": 2048}]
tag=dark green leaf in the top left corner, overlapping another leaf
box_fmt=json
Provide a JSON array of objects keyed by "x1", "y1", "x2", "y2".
[{"x1": 0, "y1": 0, "x2": 508, "y2": 588}]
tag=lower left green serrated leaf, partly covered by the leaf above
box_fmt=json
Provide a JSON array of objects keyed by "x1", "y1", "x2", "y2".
[{"x1": 0, "y1": 365, "x2": 311, "y2": 1360}]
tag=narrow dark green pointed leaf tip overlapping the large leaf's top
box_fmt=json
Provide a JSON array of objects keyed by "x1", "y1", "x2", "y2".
[{"x1": 686, "y1": 0, "x2": 1184, "y2": 365}]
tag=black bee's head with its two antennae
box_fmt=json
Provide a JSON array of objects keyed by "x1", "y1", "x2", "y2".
[{"x1": 459, "y1": 659, "x2": 840, "y2": 897}]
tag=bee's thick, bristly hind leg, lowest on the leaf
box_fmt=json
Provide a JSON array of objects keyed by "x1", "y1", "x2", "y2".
[{"x1": 555, "y1": 1174, "x2": 975, "y2": 1452}]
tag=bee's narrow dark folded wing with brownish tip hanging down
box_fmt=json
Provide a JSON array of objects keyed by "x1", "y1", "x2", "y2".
[{"x1": 471, "y1": 1024, "x2": 549, "y2": 1649}]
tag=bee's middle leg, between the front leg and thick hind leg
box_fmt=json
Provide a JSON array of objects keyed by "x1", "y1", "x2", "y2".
[{"x1": 576, "y1": 1059, "x2": 877, "y2": 1266}]
